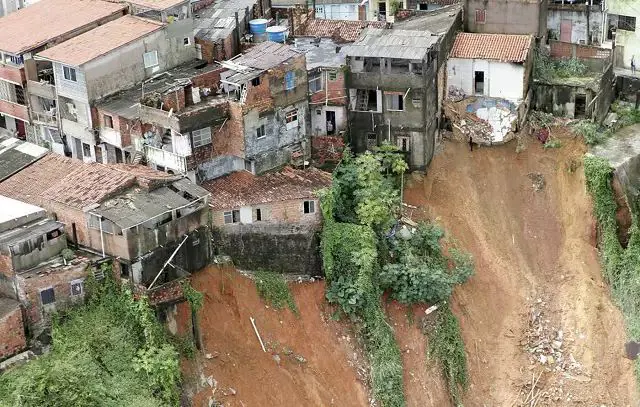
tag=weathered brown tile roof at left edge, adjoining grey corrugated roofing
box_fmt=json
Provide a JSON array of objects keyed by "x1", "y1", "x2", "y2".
[{"x1": 0, "y1": 153, "x2": 175, "y2": 209}]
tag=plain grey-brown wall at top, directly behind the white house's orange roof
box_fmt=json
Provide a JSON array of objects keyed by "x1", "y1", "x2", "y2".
[{"x1": 465, "y1": 0, "x2": 548, "y2": 37}]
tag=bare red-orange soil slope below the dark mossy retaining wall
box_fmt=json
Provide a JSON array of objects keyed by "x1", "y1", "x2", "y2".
[{"x1": 181, "y1": 266, "x2": 369, "y2": 407}]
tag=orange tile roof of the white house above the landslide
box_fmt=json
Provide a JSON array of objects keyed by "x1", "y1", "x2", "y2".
[{"x1": 449, "y1": 33, "x2": 533, "y2": 62}]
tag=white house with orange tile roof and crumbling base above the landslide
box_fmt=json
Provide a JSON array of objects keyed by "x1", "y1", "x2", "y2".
[{"x1": 446, "y1": 33, "x2": 533, "y2": 144}]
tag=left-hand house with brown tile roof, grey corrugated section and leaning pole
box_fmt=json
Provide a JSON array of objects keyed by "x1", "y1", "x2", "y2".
[{"x1": 0, "y1": 154, "x2": 209, "y2": 286}]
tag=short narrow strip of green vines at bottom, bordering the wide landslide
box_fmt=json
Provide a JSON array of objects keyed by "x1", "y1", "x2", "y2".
[{"x1": 426, "y1": 305, "x2": 469, "y2": 406}]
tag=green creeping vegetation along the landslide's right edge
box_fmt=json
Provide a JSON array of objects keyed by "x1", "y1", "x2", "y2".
[{"x1": 584, "y1": 155, "x2": 640, "y2": 383}]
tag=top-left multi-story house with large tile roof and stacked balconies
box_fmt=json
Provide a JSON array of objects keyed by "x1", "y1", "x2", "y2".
[{"x1": 0, "y1": 0, "x2": 126, "y2": 142}]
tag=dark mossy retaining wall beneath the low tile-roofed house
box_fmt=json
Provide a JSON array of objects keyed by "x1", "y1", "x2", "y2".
[{"x1": 214, "y1": 223, "x2": 322, "y2": 275}]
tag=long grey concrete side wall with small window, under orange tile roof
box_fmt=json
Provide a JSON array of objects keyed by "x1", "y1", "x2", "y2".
[{"x1": 84, "y1": 19, "x2": 196, "y2": 101}]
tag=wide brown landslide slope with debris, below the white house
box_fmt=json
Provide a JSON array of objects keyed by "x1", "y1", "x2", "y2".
[{"x1": 405, "y1": 131, "x2": 638, "y2": 407}]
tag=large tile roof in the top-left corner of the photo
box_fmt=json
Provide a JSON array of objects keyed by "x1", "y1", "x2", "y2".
[{"x1": 0, "y1": 0, "x2": 126, "y2": 54}]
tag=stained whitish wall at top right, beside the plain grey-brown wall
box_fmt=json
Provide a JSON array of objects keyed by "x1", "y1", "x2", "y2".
[{"x1": 547, "y1": 4, "x2": 604, "y2": 45}]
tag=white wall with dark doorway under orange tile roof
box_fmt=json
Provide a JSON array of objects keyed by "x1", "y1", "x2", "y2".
[{"x1": 447, "y1": 58, "x2": 525, "y2": 102}]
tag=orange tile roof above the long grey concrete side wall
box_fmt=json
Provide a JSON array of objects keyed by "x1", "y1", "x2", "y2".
[{"x1": 38, "y1": 15, "x2": 163, "y2": 66}]
